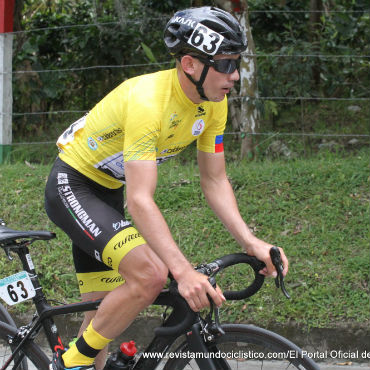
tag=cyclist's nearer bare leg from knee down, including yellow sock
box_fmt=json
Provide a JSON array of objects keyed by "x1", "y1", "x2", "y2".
[{"x1": 62, "y1": 245, "x2": 168, "y2": 367}]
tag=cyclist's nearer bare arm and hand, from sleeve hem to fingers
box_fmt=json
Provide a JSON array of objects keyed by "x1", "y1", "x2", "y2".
[{"x1": 125, "y1": 161, "x2": 225, "y2": 311}]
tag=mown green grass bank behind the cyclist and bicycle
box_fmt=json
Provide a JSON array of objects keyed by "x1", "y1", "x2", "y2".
[{"x1": 0, "y1": 148, "x2": 370, "y2": 328}]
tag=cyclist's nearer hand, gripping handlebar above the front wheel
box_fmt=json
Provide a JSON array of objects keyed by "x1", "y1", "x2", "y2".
[{"x1": 177, "y1": 270, "x2": 226, "y2": 312}]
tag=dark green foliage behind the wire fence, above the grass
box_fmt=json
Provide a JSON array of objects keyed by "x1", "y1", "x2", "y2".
[{"x1": 13, "y1": 0, "x2": 370, "y2": 151}]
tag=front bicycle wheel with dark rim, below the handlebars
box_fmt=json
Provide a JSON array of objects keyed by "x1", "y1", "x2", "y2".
[{"x1": 163, "y1": 324, "x2": 320, "y2": 370}]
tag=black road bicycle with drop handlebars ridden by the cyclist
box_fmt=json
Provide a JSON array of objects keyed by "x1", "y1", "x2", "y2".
[{"x1": 0, "y1": 220, "x2": 319, "y2": 370}]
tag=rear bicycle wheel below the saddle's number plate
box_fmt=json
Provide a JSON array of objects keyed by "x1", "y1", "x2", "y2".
[{"x1": 0, "y1": 321, "x2": 50, "y2": 370}]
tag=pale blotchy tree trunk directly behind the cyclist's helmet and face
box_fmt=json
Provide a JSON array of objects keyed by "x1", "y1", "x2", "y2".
[{"x1": 217, "y1": 0, "x2": 258, "y2": 158}]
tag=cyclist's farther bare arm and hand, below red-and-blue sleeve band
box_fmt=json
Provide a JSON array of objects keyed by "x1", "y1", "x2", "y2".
[{"x1": 198, "y1": 151, "x2": 288, "y2": 275}]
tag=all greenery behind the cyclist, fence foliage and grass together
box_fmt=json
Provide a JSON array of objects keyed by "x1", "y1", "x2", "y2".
[{"x1": 0, "y1": 0, "x2": 370, "y2": 327}]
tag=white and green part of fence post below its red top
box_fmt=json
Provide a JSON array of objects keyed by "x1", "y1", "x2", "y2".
[{"x1": 0, "y1": 33, "x2": 13, "y2": 164}]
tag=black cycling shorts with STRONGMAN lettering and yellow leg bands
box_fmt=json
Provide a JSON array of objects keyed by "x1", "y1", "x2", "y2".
[{"x1": 45, "y1": 158, "x2": 145, "y2": 293}]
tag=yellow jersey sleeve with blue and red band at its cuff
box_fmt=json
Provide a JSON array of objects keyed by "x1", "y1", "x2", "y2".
[{"x1": 197, "y1": 97, "x2": 227, "y2": 153}]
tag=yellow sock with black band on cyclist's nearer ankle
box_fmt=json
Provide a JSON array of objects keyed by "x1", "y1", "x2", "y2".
[{"x1": 62, "y1": 321, "x2": 112, "y2": 367}]
